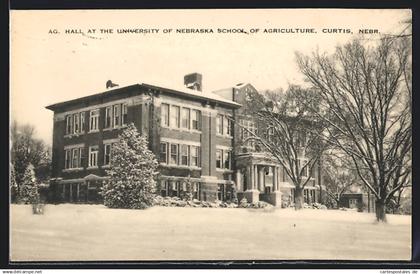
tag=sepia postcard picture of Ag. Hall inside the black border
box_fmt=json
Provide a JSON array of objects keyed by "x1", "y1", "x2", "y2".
[{"x1": 9, "y1": 9, "x2": 413, "y2": 263}]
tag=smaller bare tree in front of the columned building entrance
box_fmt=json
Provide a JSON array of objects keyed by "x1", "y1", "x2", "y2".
[{"x1": 237, "y1": 86, "x2": 328, "y2": 209}]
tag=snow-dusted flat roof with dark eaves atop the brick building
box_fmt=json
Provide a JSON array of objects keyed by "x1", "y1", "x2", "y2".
[{"x1": 46, "y1": 83, "x2": 241, "y2": 111}]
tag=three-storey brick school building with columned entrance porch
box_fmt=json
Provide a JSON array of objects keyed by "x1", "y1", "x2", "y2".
[{"x1": 47, "y1": 73, "x2": 320, "y2": 205}]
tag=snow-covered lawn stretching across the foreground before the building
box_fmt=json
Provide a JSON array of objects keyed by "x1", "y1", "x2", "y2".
[{"x1": 10, "y1": 204, "x2": 411, "y2": 261}]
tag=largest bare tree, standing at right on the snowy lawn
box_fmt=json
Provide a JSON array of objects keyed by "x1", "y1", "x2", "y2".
[{"x1": 297, "y1": 37, "x2": 412, "y2": 222}]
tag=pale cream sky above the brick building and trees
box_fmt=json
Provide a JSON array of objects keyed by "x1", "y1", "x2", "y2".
[{"x1": 10, "y1": 9, "x2": 411, "y2": 144}]
